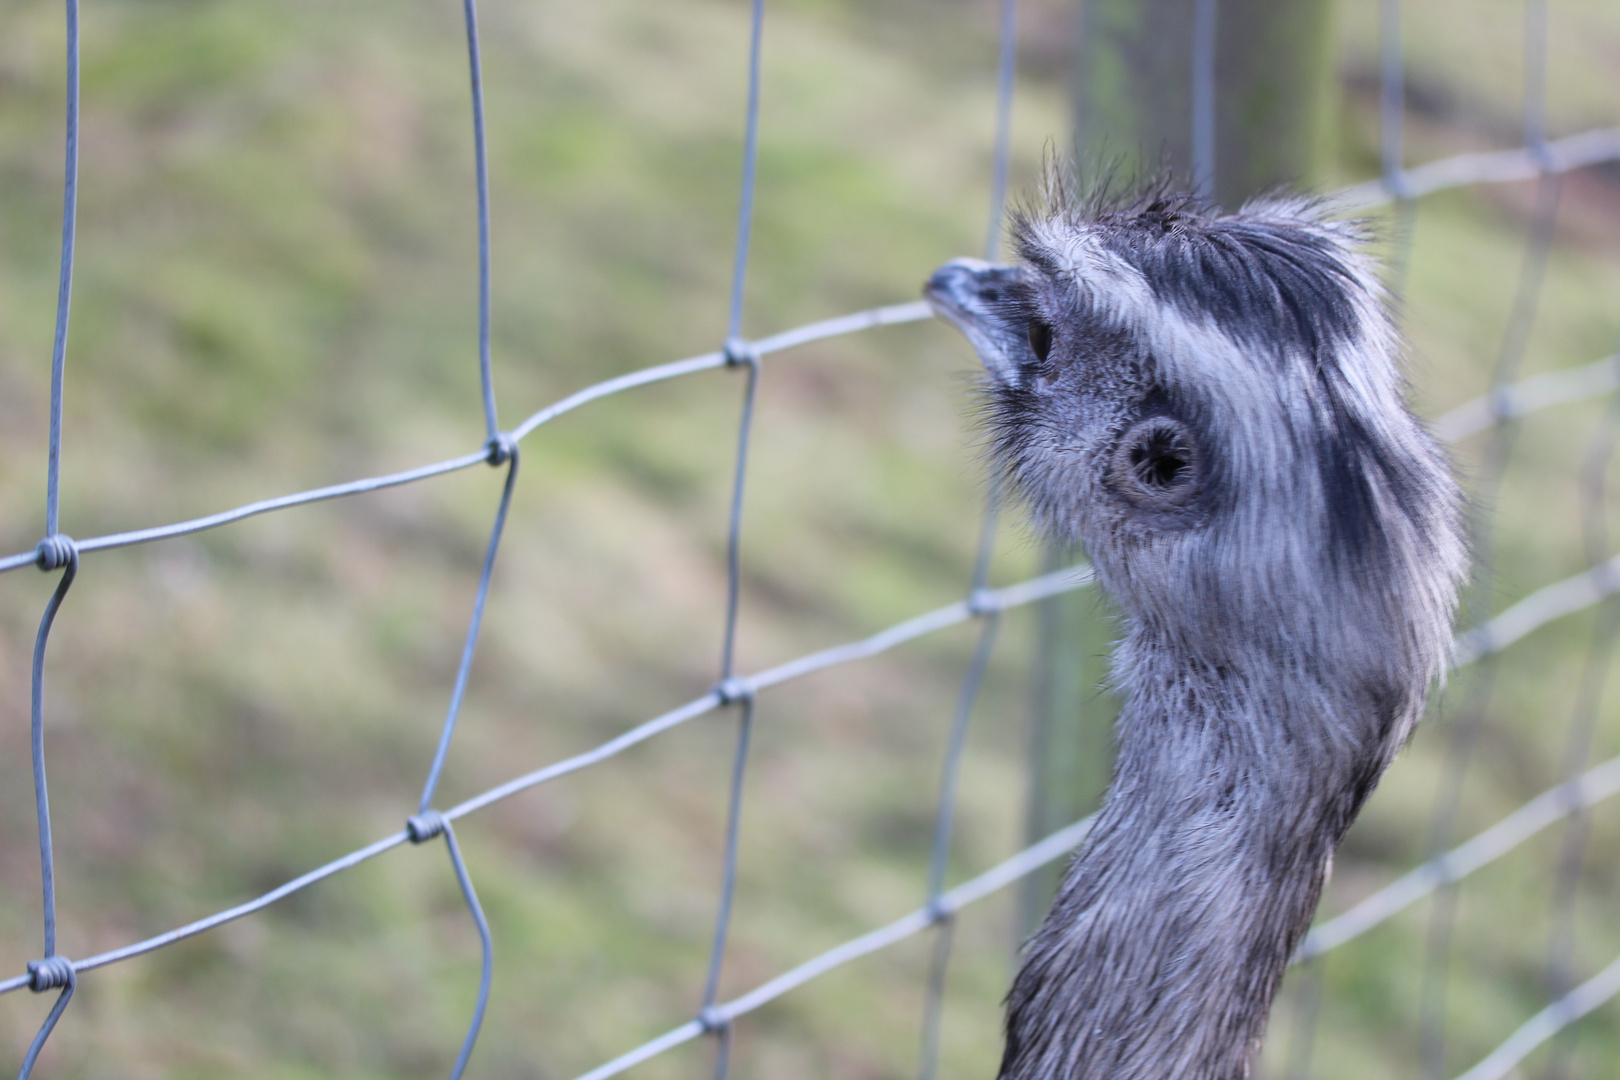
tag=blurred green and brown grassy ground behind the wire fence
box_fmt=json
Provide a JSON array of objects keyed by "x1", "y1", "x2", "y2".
[{"x1": 0, "y1": 0, "x2": 1620, "y2": 1080}]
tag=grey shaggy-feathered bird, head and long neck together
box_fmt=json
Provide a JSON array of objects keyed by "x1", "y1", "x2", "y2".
[{"x1": 925, "y1": 181, "x2": 1466, "y2": 1080}]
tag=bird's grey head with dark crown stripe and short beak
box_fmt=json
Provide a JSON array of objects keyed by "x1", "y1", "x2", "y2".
[{"x1": 925, "y1": 188, "x2": 1464, "y2": 740}]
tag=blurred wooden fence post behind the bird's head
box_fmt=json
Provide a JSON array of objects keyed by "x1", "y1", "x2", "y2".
[{"x1": 1019, "y1": 0, "x2": 1337, "y2": 934}]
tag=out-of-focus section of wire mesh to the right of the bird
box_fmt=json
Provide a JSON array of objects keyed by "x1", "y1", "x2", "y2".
[{"x1": 1290, "y1": 0, "x2": 1620, "y2": 1080}]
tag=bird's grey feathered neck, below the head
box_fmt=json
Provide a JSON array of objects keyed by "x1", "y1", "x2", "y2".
[{"x1": 1001, "y1": 636, "x2": 1390, "y2": 1080}]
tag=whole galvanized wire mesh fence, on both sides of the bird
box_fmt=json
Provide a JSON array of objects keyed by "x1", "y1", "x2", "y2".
[{"x1": 0, "y1": 0, "x2": 1620, "y2": 1080}]
